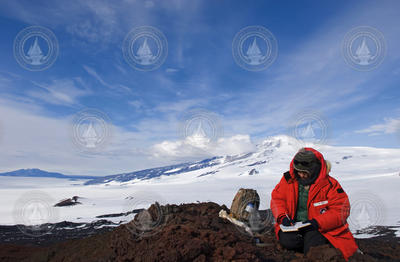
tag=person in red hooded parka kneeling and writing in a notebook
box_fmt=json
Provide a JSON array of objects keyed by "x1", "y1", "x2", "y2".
[{"x1": 271, "y1": 148, "x2": 358, "y2": 260}]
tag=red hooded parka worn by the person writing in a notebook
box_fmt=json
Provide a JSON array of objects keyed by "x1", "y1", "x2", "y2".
[{"x1": 271, "y1": 148, "x2": 358, "y2": 260}]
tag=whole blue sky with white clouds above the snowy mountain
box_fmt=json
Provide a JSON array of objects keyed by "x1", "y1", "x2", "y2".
[{"x1": 0, "y1": 0, "x2": 400, "y2": 175}]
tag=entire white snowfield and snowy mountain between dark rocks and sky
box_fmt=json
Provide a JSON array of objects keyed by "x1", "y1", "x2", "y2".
[{"x1": 0, "y1": 136, "x2": 400, "y2": 236}]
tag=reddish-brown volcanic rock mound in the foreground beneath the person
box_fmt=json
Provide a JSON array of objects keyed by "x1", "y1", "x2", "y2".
[{"x1": 0, "y1": 202, "x2": 400, "y2": 262}]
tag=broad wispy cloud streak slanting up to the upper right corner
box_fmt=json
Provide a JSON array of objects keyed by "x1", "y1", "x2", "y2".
[{"x1": 200, "y1": 0, "x2": 400, "y2": 139}]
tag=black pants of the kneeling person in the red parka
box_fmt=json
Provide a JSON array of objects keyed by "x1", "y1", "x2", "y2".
[{"x1": 278, "y1": 227, "x2": 329, "y2": 254}]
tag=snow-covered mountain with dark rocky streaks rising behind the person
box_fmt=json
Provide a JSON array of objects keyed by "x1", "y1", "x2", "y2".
[{"x1": 85, "y1": 135, "x2": 400, "y2": 188}]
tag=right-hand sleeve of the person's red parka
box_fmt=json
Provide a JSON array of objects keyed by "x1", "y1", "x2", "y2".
[{"x1": 314, "y1": 177, "x2": 350, "y2": 232}]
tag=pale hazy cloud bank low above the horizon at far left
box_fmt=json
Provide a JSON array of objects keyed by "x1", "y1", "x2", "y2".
[{"x1": 0, "y1": 98, "x2": 162, "y2": 175}]
